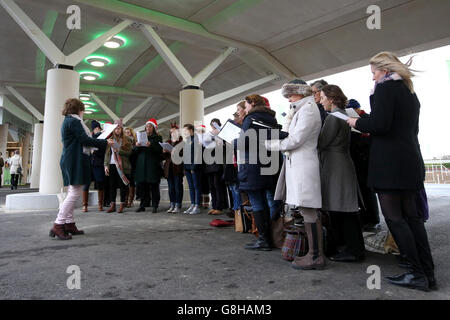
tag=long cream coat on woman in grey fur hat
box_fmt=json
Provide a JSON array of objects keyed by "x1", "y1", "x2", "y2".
[{"x1": 268, "y1": 96, "x2": 322, "y2": 209}]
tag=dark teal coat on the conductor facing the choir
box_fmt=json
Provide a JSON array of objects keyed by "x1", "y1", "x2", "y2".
[{"x1": 59, "y1": 116, "x2": 107, "y2": 186}]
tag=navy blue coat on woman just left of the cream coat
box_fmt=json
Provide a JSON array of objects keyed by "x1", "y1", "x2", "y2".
[{"x1": 235, "y1": 106, "x2": 282, "y2": 191}]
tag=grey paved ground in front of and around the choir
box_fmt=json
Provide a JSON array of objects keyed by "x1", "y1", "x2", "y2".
[{"x1": 0, "y1": 188, "x2": 450, "y2": 300}]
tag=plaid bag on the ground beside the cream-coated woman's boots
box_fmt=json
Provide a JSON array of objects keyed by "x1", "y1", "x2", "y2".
[{"x1": 281, "y1": 226, "x2": 308, "y2": 261}]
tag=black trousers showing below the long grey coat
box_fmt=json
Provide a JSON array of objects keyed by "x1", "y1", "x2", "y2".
[{"x1": 329, "y1": 211, "x2": 365, "y2": 257}]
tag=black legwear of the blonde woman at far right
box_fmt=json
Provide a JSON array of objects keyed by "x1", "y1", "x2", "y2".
[{"x1": 377, "y1": 190, "x2": 434, "y2": 276}]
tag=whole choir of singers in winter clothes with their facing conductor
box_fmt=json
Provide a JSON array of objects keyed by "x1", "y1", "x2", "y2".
[{"x1": 50, "y1": 52, "x2": 436, "y2": 290}]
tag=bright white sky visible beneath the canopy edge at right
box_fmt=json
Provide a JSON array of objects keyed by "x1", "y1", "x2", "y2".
[{"x1": 204, "y1": 45, "x2": 450, "y2": 160}]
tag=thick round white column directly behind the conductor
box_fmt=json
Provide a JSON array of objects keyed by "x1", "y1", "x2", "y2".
[{"x1": 39, "y1": 69, "x2": 80, "y2": 194}]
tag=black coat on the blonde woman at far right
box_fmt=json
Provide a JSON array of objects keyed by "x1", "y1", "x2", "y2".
[{"x1": 356, "y1": 80, "x2": 425, "y2": 190}]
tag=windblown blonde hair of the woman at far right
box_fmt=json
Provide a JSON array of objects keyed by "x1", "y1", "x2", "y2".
[{"x1": 369, "y1": 51, "x2": 416, "y2": 93}]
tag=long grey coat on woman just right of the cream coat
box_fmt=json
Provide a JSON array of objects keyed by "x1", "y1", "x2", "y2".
[{"x1": 318, "y1": 108, "x2": 359, "y2": 212}]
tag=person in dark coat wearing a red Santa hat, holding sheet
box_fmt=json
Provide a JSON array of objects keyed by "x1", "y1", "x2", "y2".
[{"x1": 135, "y1": 118, "x2": 163, "y2": 213}]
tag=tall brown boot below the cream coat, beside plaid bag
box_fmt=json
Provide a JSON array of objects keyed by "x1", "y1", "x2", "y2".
[{"x1": 292, "y1": 219, "x2": 326, "y2": 270}]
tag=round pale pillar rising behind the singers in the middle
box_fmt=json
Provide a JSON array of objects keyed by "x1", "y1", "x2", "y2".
[{"x1": 180, "y1": 86, "x2": 204, "y2": 128}]
